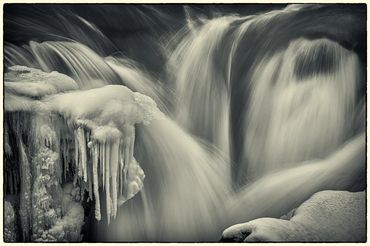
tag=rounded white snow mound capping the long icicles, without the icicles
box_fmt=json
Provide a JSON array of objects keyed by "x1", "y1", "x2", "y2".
[{"x1": 42, "y1": 85, "x2": 162, "y2": 135}]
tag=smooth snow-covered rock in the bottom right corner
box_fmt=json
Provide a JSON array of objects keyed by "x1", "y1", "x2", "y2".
[{"x1": 222, "y1": 191, "x2": 366, "y2": 242}]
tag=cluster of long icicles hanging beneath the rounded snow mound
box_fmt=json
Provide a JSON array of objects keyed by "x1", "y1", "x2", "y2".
[{"x1": 74, "y1": 123, "x2": 144, "y2": 223}]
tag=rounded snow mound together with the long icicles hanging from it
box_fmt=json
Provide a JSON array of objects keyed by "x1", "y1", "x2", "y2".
[{"x1": 39, "y1": 85, "x2": 162, "y2": 223}]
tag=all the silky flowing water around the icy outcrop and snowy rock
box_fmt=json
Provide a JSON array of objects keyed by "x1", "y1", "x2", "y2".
[{"x1": 4, "y1": 5, "x2": 366, "y2": 241}]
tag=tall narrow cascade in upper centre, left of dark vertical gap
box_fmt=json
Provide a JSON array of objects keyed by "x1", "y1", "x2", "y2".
[{"x1": 167, "y1": 17, "x2": 240, "y2": 155}]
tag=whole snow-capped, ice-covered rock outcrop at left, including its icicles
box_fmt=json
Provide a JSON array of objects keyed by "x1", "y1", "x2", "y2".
[{"x1": 4, "y1": 66, "x2": 161, "y2": 241}]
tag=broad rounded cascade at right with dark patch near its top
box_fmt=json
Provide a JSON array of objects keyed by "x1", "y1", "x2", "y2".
[{"x1": 239, "y1": 39, "x2": 360, "y2": 184}]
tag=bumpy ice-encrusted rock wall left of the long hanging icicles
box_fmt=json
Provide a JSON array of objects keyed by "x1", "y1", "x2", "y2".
[{"x1": 4, "y1": 112, "x2": 84, "y2": 242}]
